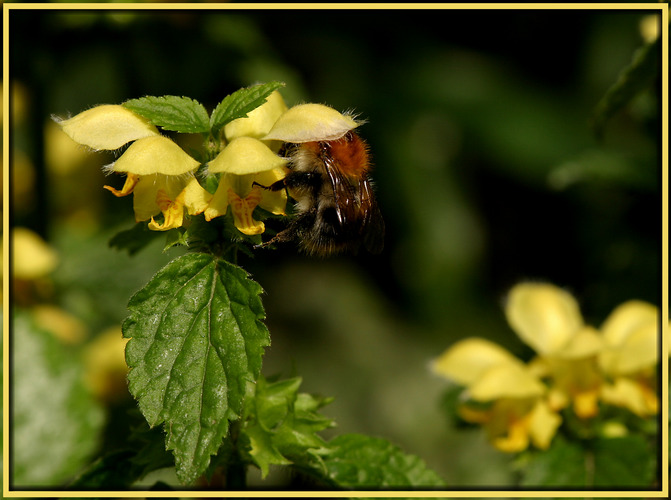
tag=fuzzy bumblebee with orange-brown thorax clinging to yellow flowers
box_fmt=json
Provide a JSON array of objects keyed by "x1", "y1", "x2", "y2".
[{"x1": 261, "y1": 131, "x2": 384, "y2": 257}]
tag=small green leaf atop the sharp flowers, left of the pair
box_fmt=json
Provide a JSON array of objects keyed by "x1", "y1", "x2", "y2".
[{"x1": 123, "y1": 95, "x2": 210, "y2": 134}]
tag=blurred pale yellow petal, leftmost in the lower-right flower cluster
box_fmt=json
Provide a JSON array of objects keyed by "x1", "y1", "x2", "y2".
[{"x1": 430, "y1": 337, "x2": 521, "y2": 386}]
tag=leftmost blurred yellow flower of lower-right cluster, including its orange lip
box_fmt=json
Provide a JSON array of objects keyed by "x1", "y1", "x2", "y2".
[{"x1": 431, "y1": 338, "x2": 561, "y2": 452}]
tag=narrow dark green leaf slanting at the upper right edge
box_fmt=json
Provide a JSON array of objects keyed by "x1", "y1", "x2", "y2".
[{"x1": 592, "y1": 37, "x2": 662, "y2": 137}]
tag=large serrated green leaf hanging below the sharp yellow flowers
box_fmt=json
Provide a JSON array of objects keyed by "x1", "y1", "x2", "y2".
[{"x1": 123, "y1": 253, "x2": 270, "y2": 483}]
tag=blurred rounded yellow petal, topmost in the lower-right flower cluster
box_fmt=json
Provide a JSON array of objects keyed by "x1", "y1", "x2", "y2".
[{"x1": 505, "y1": 283, "x2": 583, "y2": 355}]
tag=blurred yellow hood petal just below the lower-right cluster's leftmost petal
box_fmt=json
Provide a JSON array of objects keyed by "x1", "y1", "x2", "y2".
[{"x1": 469, "y1": 364, "x2": 545, "y2": 401}]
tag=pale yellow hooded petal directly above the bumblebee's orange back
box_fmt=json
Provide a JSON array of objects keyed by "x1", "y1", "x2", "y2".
[{"x1": 263, "y1": 104, "x2": 362, "y2": 143}]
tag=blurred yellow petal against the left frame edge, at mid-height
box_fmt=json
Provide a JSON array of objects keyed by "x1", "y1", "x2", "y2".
[{"x1": 11, "y1": 227, "x2": 58, "y2": 280}]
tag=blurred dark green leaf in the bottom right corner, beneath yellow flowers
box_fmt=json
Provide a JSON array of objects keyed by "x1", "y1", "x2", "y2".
[{"x1": 594, "y1": 434, "x2": 656, "y2": 489}]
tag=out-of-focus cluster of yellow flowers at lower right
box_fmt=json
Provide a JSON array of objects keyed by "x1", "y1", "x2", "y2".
[{"x1": 431, "y1": 283, "x2": 660, "y2": 452}]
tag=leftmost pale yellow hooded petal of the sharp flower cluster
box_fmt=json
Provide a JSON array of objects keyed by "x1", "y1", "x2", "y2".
[{"x1": 58, "y1": 104, "x2": 159, "y2": 149}]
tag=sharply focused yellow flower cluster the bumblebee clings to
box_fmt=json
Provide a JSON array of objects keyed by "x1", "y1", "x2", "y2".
[{"x1": 58, "y1": 91, "x2": 358, "y2": 235}]
